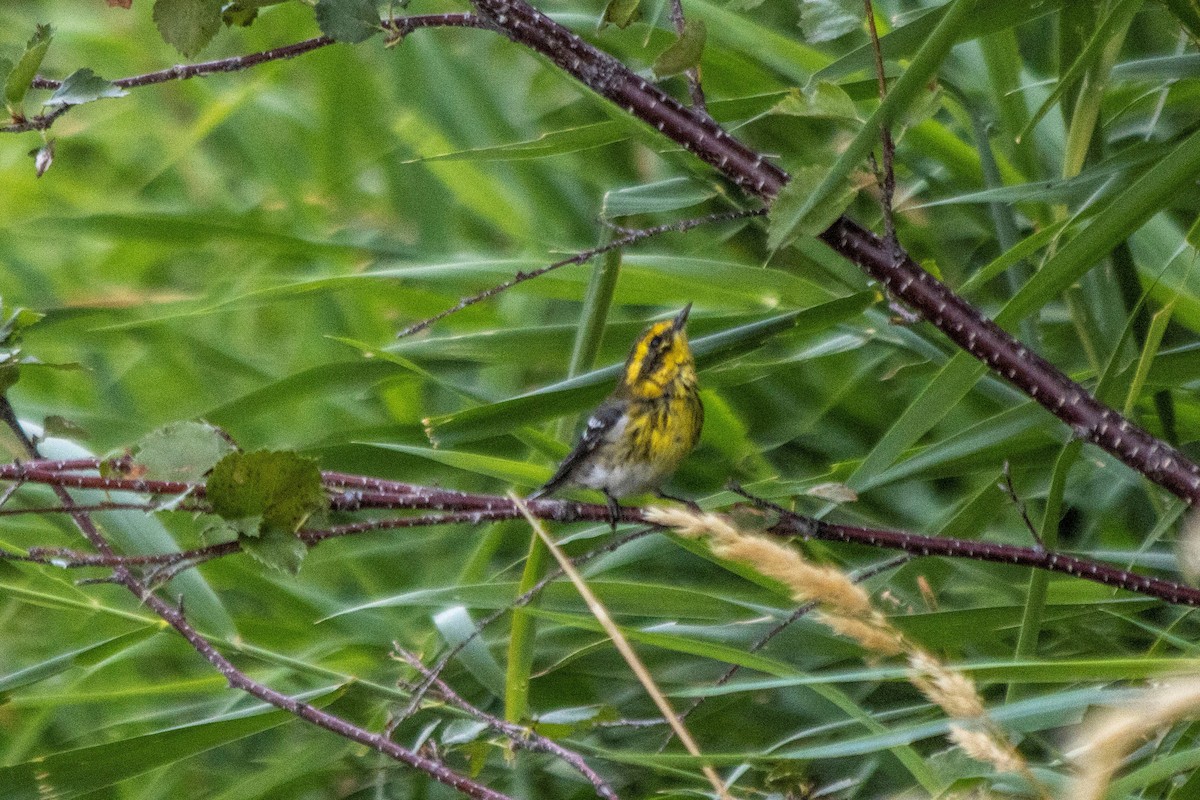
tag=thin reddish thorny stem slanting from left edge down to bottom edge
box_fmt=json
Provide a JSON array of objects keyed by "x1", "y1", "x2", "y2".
[{"x1": 0, "y1": 396, "x2": 512, "y2": 800}]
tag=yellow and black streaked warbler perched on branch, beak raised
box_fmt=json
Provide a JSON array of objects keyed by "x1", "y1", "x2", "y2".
[{"x1": 529, "y1": 303, "x2": 704, "y2": 527}]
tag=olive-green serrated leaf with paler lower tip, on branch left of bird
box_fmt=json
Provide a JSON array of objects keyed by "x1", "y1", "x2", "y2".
[{"x1": 206, "y1": 450, "x2": 329, "y2": 573}]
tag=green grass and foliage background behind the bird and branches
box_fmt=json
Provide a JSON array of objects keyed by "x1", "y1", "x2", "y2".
[{"x1": 0, "y1": 0, "x2": 1200, "y2": 800}]
